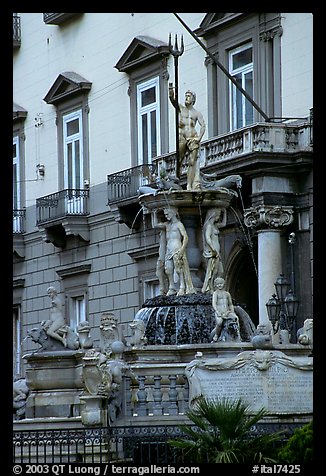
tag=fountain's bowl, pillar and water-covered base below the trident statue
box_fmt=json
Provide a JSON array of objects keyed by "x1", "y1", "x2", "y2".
[{"x1": 135, "y1": 171, "x2": 255, "y2": 345}]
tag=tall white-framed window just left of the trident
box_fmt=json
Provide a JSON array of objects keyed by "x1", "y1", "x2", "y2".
[{"x1": 137, "y1": 77, "x2": 161, "y2": 165}]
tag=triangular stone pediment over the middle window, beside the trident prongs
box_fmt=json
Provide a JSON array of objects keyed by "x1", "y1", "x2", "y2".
[{"x1": 115, "y1": 36, "x2": 169, "y2": 73}]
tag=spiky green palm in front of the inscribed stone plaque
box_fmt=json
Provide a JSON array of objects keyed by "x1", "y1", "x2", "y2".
[{"x1": 169, "y1": 396, "x2": 281, "y2": 463}]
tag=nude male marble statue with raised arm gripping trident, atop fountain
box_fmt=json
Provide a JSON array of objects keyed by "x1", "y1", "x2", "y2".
[{"x1": 169, "y1": 83, "x2": 206, "y2": 190}]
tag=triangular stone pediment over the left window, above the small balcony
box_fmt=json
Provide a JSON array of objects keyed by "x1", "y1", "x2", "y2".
[{"x1": 43, "y1": 71, "x2": 92, "y2": 104}]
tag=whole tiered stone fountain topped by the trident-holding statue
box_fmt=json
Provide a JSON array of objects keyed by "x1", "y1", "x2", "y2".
[{"x1": 131, "y1": 65, "x2": 255, "y2": 345}]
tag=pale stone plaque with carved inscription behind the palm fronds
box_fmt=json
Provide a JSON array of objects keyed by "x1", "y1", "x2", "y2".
[{"x1": 186, "y1": 350, "x2": 313, "y2": 414}]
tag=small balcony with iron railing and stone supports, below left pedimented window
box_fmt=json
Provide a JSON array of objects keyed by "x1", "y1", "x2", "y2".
[{"x1": 36, "y1": 189, "x2": 89, "y2": 248}]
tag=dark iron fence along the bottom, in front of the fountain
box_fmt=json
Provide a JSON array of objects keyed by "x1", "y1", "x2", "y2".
[{"x1": 13, "y1": 423, "x2": 302, "y2": 465}]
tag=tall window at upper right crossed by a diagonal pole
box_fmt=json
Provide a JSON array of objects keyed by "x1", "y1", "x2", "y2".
[{"x1": 229, "y1": 43, "x2": 253, "y2": 130}]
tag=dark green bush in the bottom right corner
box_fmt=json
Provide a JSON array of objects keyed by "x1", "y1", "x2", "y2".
[{"x1": 278, "y1": 420, "x2": 313, "y2": 464}]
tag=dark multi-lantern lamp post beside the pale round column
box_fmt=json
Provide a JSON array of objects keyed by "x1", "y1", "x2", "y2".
[{"x1": 266, "y1": 273, "x2": 299, "y2": 341}]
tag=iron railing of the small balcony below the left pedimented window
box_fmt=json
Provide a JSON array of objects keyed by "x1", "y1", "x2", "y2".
[{"x1": 36, "y1": 189, "x2": 89, "y2": 225}]
